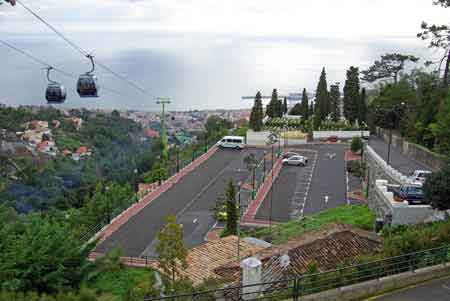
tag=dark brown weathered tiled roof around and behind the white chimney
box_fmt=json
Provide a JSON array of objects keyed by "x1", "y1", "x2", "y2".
[{"x1": 215, "y1": 224, "x2": 381, "y2": 282}]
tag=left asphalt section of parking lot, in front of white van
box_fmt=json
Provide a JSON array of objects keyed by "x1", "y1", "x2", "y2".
[{"x1": 97, "y1": 148, "x2": 262, "y2": 257}]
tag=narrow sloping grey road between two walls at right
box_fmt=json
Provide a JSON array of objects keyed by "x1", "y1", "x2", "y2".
[{"x1": 369, "y1": 136, "x2": 429, "y2": 176}]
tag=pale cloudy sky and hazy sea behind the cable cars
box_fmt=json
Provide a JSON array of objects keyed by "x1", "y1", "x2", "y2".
[{"x1": 0, "y1": 0, "x2": 450, "y2": 110}]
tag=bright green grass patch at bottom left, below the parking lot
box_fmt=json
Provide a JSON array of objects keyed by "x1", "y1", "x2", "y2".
[{"x1": 89, "y1": 267, "x2": 153, "y2": 301}]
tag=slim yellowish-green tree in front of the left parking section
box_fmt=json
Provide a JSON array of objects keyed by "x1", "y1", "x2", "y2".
[{"x1": 156, "y1": 215, "x2": 188, "y2": 283}]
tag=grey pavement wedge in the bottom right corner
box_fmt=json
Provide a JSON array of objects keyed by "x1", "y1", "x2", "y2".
[{"x1": 370, "y1": 278, "x2": 450, "y2": 301}]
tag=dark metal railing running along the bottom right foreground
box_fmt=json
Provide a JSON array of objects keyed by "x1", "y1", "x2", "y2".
[{"x1": 144, "y1": 245, "x2": 450, "y2": 301}]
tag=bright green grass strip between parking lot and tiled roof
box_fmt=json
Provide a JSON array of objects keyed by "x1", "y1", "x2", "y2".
[{"x1": 248, "y1": 205, "x2": 375, "y2": 244}]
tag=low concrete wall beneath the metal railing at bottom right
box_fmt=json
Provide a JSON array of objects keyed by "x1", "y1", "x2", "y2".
[{"x1": 301, "y1": 263, "x2": 450, "y2": 301}]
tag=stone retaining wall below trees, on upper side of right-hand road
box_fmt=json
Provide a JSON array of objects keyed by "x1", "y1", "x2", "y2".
[{"x1": 377, "y1": 128, "x2": 445, "y2": 171}]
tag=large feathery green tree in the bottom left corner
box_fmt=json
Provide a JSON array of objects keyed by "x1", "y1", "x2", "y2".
[{"x1": 0, "y1": 214, "x2": 93, "y2": 294}]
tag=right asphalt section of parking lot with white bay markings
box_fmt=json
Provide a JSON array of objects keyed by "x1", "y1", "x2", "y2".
[{"x1": 256, "y1": 144, "x2": 348, "y2": 222}]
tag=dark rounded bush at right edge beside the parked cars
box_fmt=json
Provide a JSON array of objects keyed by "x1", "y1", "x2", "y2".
[{"x1": 423, "y1": 164, "x2": 450, "y2": 210}]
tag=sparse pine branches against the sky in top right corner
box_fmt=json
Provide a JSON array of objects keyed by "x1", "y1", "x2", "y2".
[{"x1": 417, "y1": 0, "x2": 450, "y2": 85}]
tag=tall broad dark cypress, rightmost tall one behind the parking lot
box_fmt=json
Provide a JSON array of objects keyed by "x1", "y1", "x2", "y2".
[{"x1": 344, "y1": 66, "x2": 361, "y2": 123}]
